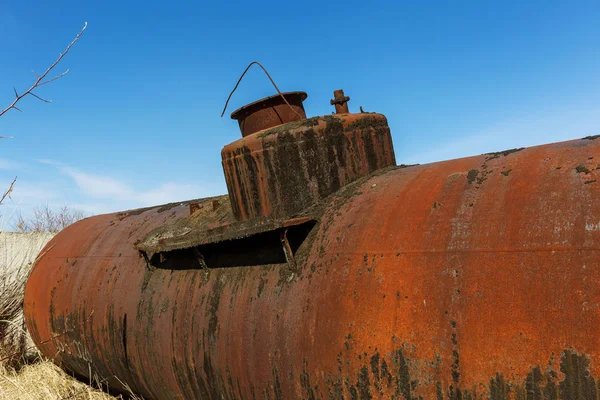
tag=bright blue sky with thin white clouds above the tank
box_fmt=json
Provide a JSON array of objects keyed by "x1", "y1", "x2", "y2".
[{"x1": 0, "y1": 0, "x2": 600, "y2": 222}]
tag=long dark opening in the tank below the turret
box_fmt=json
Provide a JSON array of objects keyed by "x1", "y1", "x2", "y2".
[{"x1": 149, "y1": 220, "x2": 316, "y2": 270}]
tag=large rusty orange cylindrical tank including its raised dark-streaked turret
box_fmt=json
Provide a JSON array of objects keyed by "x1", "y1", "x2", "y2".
[{"x1": 25, "y1": 86, "x2": 600, "y2": 400}]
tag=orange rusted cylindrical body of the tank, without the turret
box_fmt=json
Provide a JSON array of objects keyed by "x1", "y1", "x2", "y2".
[{"x1": 25, "y1": 137, "x2": 600, "y2": 400}]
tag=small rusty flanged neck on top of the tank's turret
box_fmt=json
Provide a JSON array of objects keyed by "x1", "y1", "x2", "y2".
[{"x1": 231, "y1": 92, "x2": 307, "y2": 137}]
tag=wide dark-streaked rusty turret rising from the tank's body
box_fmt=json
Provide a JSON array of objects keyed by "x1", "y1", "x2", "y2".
[{"x1": 221, "y1": 113, "x2": 396, "y2": 220}]
